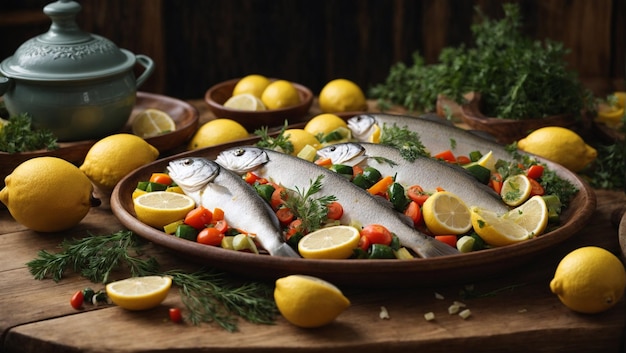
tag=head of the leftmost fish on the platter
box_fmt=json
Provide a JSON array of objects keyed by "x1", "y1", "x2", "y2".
[{"x1": 167, "y1": 157, "x2": 220, "y2": 192}]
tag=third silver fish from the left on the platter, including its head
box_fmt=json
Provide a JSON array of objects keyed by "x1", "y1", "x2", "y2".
[{"x1": 318, "y1": 142, "x2": 509, "y2": 214}]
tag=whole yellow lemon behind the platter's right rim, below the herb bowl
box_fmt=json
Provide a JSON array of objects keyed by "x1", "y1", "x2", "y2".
[{"x1": 517, "y1": 126, "x2": 598, "y2": 172}]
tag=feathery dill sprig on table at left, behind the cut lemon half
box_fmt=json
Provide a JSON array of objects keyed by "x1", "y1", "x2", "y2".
[{"x1": 27, "y1": 230, "x2": 159, "y2": 283}]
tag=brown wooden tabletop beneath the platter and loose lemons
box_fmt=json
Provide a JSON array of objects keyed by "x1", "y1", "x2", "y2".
[{"x1": 0, "y1": 99, "x2": 626, "y2": 353}]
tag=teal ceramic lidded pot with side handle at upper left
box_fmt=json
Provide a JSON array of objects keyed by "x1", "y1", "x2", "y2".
[{"x1": 0, "y1": 0, "x2": 154, "y2": 141}]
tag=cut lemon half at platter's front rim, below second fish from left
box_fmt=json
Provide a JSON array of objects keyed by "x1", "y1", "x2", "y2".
[{"x1": 298, "y1": 226, "x2": 361, "y2": 259}]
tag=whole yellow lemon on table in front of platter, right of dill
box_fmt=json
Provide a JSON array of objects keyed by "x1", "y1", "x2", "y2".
[{"x1": 274, "y1": 275, "x2": 350, "y2": 328}]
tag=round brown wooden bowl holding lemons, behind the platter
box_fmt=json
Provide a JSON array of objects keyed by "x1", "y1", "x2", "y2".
[{"x1": 204, "y1": 78, "x2": 313, "y2": 132}]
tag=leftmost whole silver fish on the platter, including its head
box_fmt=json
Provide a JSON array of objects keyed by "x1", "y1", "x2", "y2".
[{"x1": 167, "y1": 157, "x2": 300, "y2": 257}]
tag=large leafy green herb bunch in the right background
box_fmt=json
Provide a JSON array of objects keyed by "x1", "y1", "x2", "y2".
[{"x1": 369, "y1": 4, "x2": 595, "y2": 120}]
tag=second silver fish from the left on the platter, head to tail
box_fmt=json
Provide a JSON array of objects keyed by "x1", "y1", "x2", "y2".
[{"x1": 216, "y1": 146, "x2": 459, "y2": 258}]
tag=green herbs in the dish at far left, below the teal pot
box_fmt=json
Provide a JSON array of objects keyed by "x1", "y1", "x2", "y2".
[{"x1": 0, "y1": 113, "x2": 59, "y2": 153}]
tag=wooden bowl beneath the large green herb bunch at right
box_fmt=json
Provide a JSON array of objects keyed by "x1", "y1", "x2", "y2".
[{"x1": 460, "y1": 93, "x2": 585, "y2": 144}]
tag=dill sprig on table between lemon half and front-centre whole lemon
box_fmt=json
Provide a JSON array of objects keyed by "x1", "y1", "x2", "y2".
[{"x1": 165, "y1": 271, "x2": 277, "y2": 332}]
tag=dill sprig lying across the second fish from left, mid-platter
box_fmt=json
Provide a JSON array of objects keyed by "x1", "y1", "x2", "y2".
[{"x1": 285, "y1": 174, "x2": 337, "y2": 233}]
